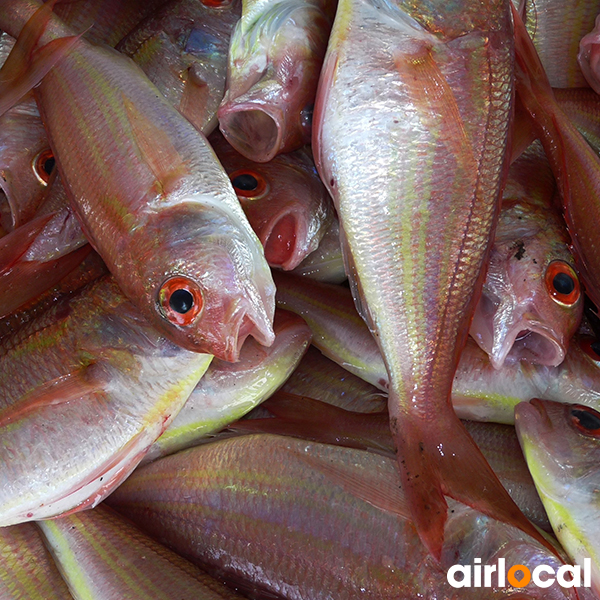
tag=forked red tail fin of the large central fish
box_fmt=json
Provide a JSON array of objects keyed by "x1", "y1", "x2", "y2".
[{"x1": 390, "y1": 395, "x2": 554, "y2": 560}]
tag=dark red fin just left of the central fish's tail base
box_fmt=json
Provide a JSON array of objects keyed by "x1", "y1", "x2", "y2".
[{"x1": 229, "y1": 392, "x2": 395, "y2": 456}]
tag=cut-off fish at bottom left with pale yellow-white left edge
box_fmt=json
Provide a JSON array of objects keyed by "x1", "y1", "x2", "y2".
[{"x1": 37, "y1": 504, "x2": 242, "y2": 600}]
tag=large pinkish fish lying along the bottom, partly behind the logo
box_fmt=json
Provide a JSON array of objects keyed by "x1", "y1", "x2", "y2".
[{"x1": 108, "y1": 435, "x2": 575, "y2": 600}]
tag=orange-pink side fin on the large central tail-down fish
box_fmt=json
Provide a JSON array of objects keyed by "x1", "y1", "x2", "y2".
[{"x1": 395, "y1": 44, "x2": 479, "y2": 177}]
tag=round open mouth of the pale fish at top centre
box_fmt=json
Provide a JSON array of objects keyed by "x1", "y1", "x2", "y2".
[{"x1": 219, "y1": 102, "x2": 284, "y2": 163}]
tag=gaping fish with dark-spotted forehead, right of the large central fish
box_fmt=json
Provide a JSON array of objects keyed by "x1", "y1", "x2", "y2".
[{"x1": 469, "y1": 144, "x2": 583, "y2": 369}]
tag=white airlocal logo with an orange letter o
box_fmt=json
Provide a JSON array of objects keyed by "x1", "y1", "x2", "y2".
[{"x1": 447, "y1": 558, "x2": 592, "y2": 588}]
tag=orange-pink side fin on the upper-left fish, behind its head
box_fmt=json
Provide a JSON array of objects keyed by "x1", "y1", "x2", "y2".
[{"x1": 121, "y1": 94, "x2": 187, "y2": 196}]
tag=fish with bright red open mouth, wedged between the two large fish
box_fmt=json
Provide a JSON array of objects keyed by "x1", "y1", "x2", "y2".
[{"x1": 209, "y1": 134, "x2": 334, "y2": 271}]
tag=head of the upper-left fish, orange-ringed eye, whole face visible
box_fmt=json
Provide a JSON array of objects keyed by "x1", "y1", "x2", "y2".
[{"x1": 134, "y1": 197, "x2": 275, "y2": 361}]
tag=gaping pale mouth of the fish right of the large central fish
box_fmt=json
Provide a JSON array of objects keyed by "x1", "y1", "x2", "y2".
[{"x1": 490, "y1": 321, "x2": 566, "y2": 369}]
